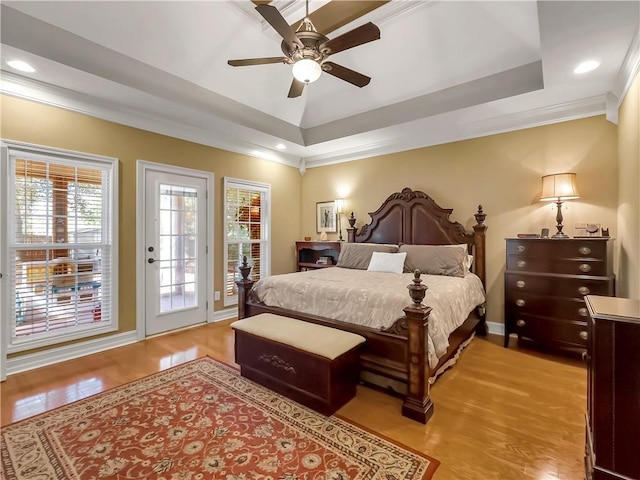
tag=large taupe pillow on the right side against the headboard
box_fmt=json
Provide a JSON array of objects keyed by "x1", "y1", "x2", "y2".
[{"x1": 400, "y1": 245, "x2": 467, "y2": 277}]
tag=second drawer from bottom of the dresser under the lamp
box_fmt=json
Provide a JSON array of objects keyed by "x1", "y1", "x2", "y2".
[{"x1": 505, "y1": 292, "x2": 589, "y2": 322}]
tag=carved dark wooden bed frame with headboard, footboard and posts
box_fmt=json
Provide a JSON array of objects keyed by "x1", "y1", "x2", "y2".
[{"x1": 236, "y1": 188, "x2": 487, "y2": 423}]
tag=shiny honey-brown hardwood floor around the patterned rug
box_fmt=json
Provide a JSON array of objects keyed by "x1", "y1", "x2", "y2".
[{"x1": 0, "y1": 322, "x2": 586, "y2": 480}]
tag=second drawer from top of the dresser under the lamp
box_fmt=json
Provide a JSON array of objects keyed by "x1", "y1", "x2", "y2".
[{"x1": 507, "y1": 256, "x2": 608, "y2": 277}]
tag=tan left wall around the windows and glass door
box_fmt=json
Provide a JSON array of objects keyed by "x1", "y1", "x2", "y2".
[{"x1": 0, "y1": 96, "x2": 302, "y2": 352}]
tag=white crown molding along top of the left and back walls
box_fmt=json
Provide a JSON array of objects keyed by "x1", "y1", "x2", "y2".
[{"x1": 0, "y1": 71, "x2": 615, "y2": 170}]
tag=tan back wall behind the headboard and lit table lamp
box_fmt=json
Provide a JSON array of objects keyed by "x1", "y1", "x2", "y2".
[{"x1": 302, "y1": 116, "x2": 620, "y2": 322}]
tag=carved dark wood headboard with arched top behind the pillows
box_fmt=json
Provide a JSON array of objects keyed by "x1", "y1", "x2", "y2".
[{"x1": 347, "y1": 188, "x2": 487, "y2": 284}]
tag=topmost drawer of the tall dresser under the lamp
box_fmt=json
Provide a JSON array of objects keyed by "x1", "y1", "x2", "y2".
[{"x1": 507, "y1": 239, "x2": 607, "y2": 261}]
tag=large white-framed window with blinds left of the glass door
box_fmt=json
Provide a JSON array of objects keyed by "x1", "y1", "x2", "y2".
[{"x1": 2, "y1": 143, "x2": 118, "y2": 352}]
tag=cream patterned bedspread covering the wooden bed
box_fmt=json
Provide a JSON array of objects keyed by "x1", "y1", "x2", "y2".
[{"x1": 253, "y1": 267, "x2": 485, "y2": 368}]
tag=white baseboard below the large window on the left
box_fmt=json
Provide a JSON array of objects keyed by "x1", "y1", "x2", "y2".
[{"x1": 7, "y1": 330, "x2": 138, "y2": 375}]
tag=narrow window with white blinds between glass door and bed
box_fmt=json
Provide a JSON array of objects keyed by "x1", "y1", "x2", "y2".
[{"x1": 224, "y1": 178, "x2": 271, "y2": 306}]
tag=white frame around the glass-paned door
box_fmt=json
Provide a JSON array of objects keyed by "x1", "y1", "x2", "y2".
[{"x1": 136, "y1": 160, "x2": 215, "y2": 341}]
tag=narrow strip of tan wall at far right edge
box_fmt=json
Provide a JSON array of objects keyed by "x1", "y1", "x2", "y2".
[{"x1": 617, "y1": 71, "x2": 640, "y2": 299}]
